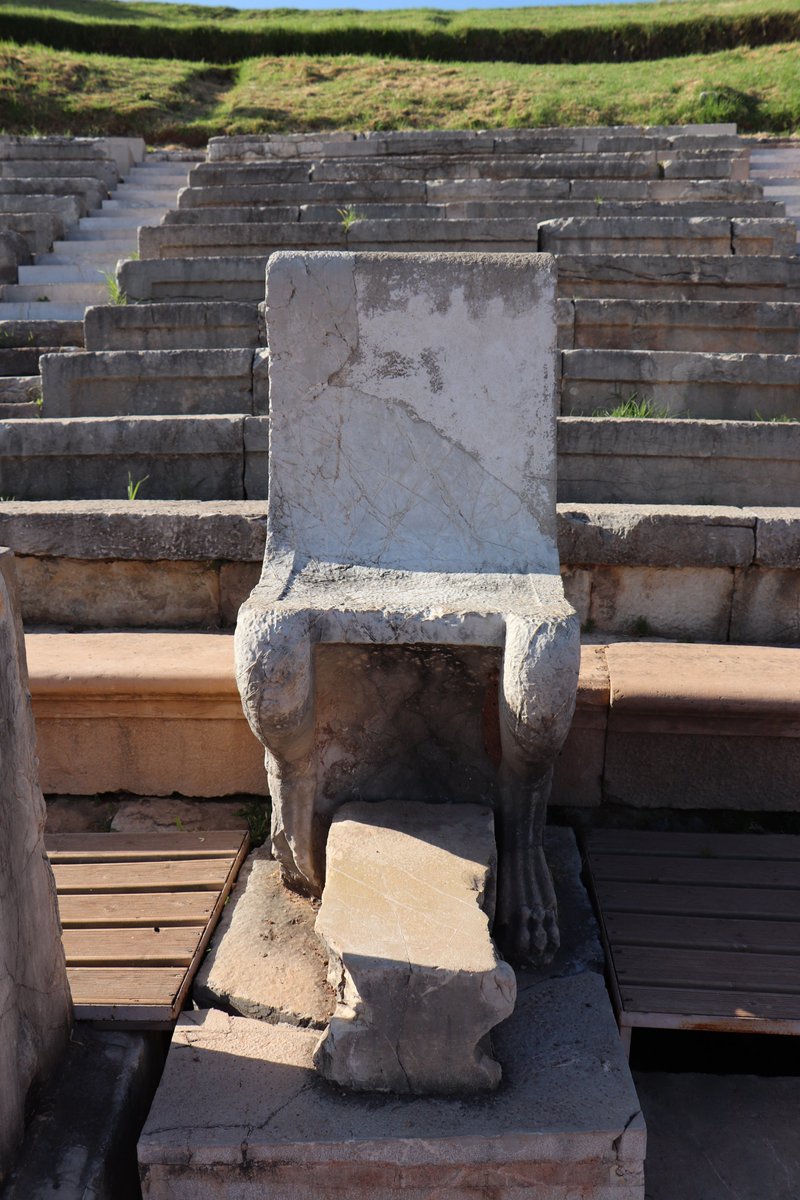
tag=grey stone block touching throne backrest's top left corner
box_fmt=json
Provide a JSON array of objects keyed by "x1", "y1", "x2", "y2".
[{"x1": 116, "y1": 254, "x2": 269, "y2": 304}]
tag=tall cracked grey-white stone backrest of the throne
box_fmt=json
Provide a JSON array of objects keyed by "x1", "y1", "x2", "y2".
[{"x1": 266, "y1": 252, "x2": 558, "y2": 574}]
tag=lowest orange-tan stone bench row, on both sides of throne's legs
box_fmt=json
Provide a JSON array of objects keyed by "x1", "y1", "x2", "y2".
[{"x1": 20, "y1": 630, "x2": 800, "y2": 811}]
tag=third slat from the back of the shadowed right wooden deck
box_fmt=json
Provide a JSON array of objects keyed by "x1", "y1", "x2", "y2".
[{"x1": 595, "y1": 881, "x2": 798, "y2": 920}]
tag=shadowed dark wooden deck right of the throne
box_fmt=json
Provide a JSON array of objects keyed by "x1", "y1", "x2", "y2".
[{"x1": 588, "y1": 829, "x2": 800, "y2": 1046}]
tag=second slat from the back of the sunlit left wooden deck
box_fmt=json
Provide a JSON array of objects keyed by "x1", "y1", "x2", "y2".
[{"x1": 53, "y1": 858, "x2": 230, "y2": 895}]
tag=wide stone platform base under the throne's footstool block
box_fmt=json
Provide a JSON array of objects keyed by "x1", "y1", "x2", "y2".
[{"x1": 139, "y1": 972, "x2": 645, "y2": 1200}]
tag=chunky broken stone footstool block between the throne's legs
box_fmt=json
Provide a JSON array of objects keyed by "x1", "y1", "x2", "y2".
[{"x1": 314, "y1": 802, "x2": 517, "y2": 1096}]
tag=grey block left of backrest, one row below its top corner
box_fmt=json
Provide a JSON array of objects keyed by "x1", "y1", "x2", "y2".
[{"x1": 84, "y1": 300, "x2": 259, "y2": 350}]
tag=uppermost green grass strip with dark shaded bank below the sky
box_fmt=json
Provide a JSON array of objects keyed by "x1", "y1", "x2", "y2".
[{"x1": 0, "y1": 0, "x2": 800, "y2": 62}]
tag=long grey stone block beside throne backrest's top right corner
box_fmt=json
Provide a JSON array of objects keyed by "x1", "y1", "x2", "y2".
[{"x1": 559, "y1": 251, "x2": 800, "y2": 301}]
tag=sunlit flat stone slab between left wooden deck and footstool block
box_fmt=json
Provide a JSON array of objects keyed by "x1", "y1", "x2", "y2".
[{"x1": 192, "y1": 848, "x2": 335, "y2": 1031}]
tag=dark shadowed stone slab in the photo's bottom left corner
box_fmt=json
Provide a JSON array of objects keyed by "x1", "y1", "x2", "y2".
[{"x1": 2, "y1": 1021, "x2": 164, "y2": 1200}]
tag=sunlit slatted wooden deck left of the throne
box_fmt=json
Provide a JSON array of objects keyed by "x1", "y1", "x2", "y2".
[{"x1": 46, "y1": 832, "x2": 249, "y2": 1028}]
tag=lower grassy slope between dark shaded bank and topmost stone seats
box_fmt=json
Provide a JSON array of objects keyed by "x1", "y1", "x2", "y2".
[{"x1": 0, "y1": 42, "x2": 800, "y2": 145}]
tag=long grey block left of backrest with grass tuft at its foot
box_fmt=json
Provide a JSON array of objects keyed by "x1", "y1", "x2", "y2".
[{"x1": 0, "y1": 416, "x2": 243, "y2": 500}]
